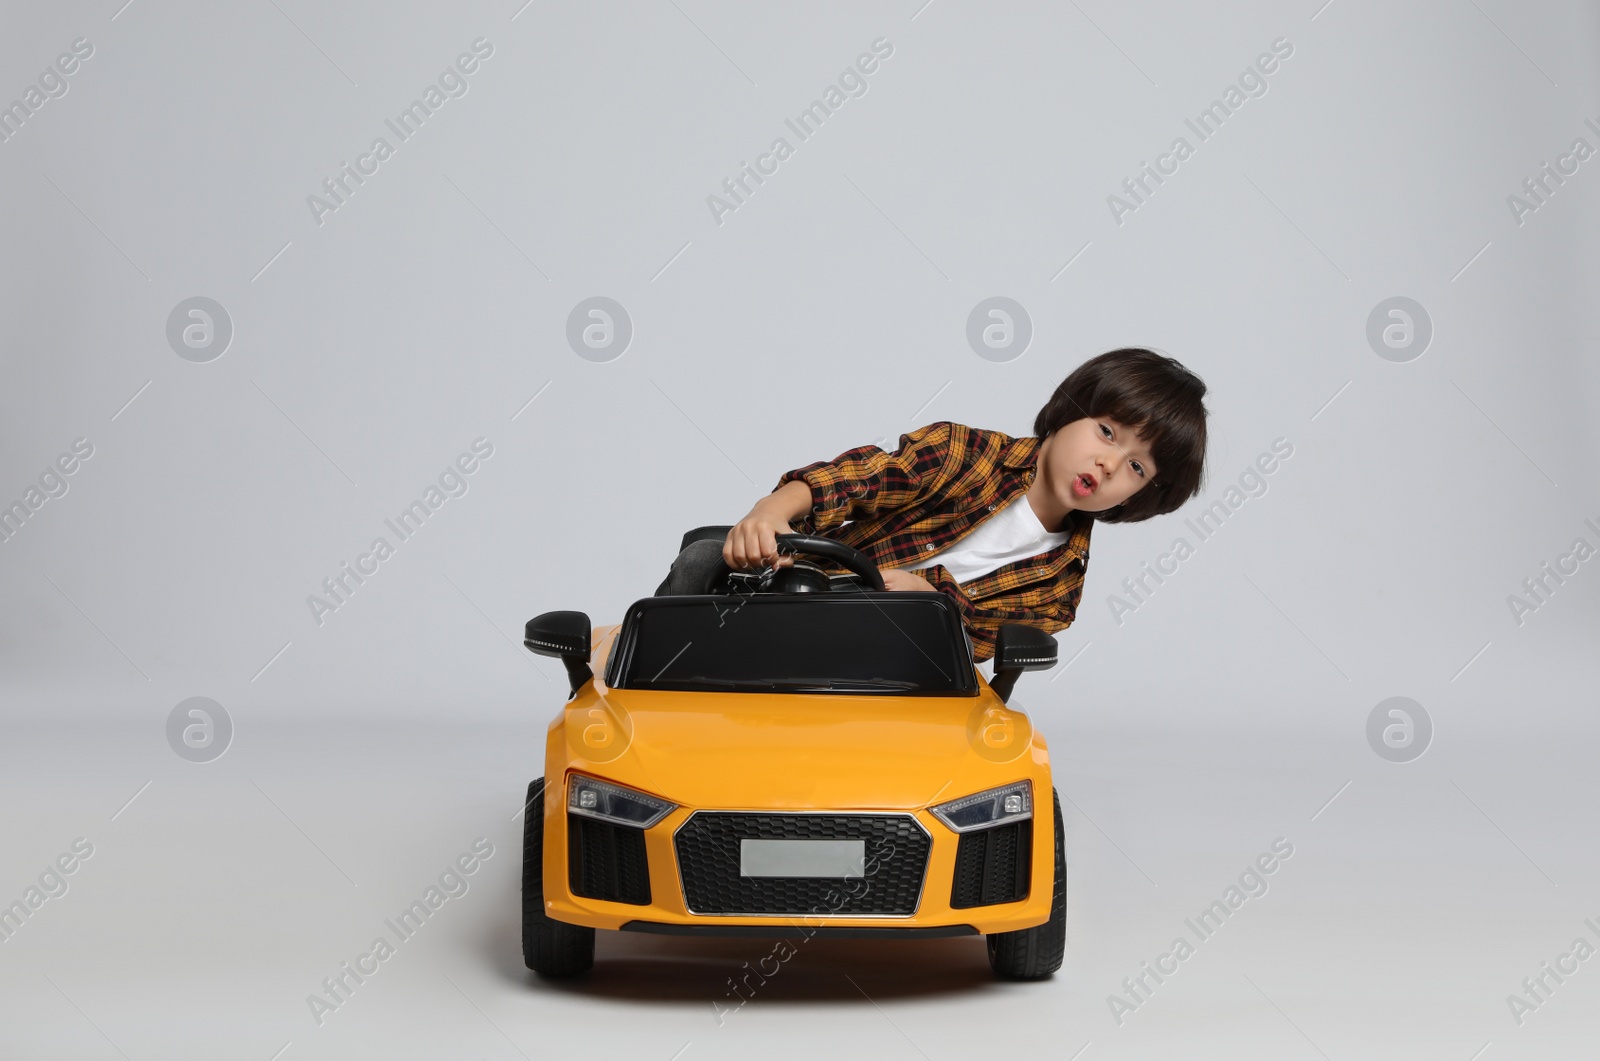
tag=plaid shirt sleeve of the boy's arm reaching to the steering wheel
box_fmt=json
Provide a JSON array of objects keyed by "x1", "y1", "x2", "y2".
[{"x1": 773, "y1": 421, "x2": 954, "y2": 535}]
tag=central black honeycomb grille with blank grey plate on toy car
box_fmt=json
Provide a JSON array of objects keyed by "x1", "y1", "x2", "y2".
[{"x1": 674, "y1": 811, "x2": 933, "y2": 917}]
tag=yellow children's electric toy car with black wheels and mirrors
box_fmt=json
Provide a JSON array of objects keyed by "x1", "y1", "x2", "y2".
[{"x1": 522, "y1": 526, "x2": 1067, "y2": 979}]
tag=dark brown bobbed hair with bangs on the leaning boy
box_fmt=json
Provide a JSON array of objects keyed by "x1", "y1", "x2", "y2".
[{"x1": 1034, "y1": 346, "x2": 1206, "y2": 523}]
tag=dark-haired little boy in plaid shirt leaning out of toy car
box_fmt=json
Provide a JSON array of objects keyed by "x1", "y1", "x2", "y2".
[{"x1": 656, "y1": 347, "x2": 1206, "y2": 663}]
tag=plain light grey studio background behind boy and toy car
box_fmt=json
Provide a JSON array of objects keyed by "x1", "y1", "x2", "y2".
[{"x1": 0, "y1": 0, "x2": 1600, "y2": 1061}]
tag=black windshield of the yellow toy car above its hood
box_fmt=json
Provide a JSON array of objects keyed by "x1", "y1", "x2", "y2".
[{"x1": 606, "y1": 592, "x2": 978, "y2": 696}]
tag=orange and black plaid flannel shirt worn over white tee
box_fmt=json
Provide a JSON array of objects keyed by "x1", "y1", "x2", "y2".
[{"x1": 774, "y1": 421, "x2": 1094, "y2": 663}]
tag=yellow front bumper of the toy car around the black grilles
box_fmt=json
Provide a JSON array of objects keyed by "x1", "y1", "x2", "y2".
[{"x1": 544, "y1": 793, "x2": 1054, "y2": 938}]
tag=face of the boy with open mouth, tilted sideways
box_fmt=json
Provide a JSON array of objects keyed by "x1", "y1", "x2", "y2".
[{"x1": 1037, "y1": 416, "x2": 1157, "y2": 512}]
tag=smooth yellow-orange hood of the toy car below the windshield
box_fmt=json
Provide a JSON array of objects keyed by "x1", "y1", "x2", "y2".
[{"x1": 565, "y1": 688, "x2": 1045, "y2": 810}]
